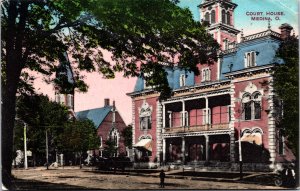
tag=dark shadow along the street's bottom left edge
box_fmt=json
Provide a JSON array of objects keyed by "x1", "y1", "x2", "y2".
[{"x1": 12, "y1": 179, "x2": 103, "y2": 190}]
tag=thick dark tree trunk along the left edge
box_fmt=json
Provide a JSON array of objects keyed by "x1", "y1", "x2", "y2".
[{"x1": 1, "y1": 1, "x2": 28, "y2": 188}]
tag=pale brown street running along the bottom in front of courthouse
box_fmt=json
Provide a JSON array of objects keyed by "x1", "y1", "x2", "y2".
[{"x1": 13, "y1": 167, "x2": 282, "y2": 190}]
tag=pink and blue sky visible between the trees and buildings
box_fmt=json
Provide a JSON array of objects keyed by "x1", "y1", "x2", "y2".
[{"x1": 35, "y1": 0, "x2": 299, "y2": 125}]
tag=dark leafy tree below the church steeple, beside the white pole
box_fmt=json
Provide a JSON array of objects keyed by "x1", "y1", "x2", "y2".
[{"x1": 14, "y1": 95, "x2": 68, "y2": 164}]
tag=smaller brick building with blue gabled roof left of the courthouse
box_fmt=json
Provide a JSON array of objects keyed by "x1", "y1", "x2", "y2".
[{"x1": 76, "y1": 99, "x2": 128, "y2": 157}]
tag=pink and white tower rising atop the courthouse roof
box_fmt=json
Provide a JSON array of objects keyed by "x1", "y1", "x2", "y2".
[{"x1": 198, "y1": 0, "x2": 240, "y2": 50}]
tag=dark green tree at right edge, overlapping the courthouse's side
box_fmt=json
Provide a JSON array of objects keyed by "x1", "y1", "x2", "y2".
[{"x1": 274, "y1": 36, "x2": 299, "y2": 157}]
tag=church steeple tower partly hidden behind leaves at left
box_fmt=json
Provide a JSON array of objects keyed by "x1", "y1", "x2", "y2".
[{"x1": 54, "y1": 52, "x2": 75, "y2": 118}]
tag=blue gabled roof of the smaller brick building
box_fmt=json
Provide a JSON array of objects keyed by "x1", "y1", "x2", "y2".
[{"x1": 75, "y1": 106, "x2": 112, "y2": 128}]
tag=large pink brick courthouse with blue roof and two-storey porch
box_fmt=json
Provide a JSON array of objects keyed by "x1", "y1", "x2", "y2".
[{"x1": 128, "y1": 0, "x2": 295, "y2": 170}]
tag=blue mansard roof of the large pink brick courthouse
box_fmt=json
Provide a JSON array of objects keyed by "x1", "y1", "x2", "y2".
[{"x1": 128, "y1": 28, "x2": 283, "y2": 95}]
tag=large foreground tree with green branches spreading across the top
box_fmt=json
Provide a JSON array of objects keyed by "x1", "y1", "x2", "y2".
[{"x1": 1, "y1": 0, "x2": 218, "y2": 186}]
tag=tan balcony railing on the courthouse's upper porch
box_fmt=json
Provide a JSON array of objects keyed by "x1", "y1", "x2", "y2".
[{"x1": 165, "y1": 123, "x2": 229, "y2": 133}]
